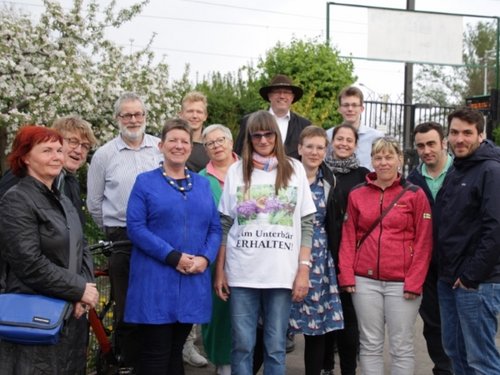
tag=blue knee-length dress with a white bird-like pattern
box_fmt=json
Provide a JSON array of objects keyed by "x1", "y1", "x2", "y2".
[{"x1": 289, "y1": 171, "x2": 344, "y2": 336}]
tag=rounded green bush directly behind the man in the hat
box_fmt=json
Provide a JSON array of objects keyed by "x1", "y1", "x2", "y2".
[{"x1": 258, "y1": 39, "x2": 356, "y2": 128}]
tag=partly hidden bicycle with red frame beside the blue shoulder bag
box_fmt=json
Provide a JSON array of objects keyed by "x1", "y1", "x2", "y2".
[{"x1": 88, "y1": 240, "x2": 131, "y2": 375}]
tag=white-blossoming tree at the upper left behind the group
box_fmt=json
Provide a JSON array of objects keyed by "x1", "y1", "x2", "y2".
[{"x1": 0, "y1": 0, "x2": 190, "y2": 170}]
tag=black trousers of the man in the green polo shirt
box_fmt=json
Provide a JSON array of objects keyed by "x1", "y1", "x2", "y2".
[{"x1": 419, "y1": 263, "x2": 453, "y2": 375}]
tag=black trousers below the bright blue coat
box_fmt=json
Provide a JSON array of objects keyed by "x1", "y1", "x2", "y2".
[{"x1": 139, "y1": 323, "x2": 193, "y2": 375}]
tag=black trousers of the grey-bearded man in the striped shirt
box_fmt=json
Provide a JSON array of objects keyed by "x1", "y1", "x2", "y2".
[{"x1": 105, "y1": 227, "x2": 141, "y2": 368}]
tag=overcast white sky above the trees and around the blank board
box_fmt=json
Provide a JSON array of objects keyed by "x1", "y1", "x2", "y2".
[{"x1": 5, "y1": 0, "x2": 500, "y2": 100}]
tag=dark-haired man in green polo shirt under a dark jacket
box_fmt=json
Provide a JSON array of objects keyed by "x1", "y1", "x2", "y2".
[{"x1": 408, "y1": 122, "x2": 453, "y2": 375}]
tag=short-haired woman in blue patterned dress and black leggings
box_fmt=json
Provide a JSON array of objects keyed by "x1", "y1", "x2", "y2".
[{"x1": 290, "y1": 125, "x2": 344, "y2": 375}]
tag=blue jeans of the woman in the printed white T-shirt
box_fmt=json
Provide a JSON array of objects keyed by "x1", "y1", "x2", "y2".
[{"x1": 229, "y1": 287, "x2": 292, "y2": 375}]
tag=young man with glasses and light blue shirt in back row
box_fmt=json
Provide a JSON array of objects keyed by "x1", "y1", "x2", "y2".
[{"x1": 326, "y1": 86, "x2": 384, "y2": 171}]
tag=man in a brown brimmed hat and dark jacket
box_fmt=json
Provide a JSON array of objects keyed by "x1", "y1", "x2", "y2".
[{"x1": 234, "y1": 74, "x2": 311, "y2": 159}]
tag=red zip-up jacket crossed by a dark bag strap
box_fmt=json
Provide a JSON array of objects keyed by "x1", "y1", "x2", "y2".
[{"x1": 338, "y1": 173, "x2": 432, "y2": 294}]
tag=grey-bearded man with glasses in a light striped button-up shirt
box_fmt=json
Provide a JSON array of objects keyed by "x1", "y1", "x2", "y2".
[{"x1": 87, "y1": 92, "x2": 163, "y2": 373}]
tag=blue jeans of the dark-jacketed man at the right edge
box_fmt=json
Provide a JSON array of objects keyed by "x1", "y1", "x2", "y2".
[{"x1": 438, "y1": 280, "x2": 500, "y2": 375}]
